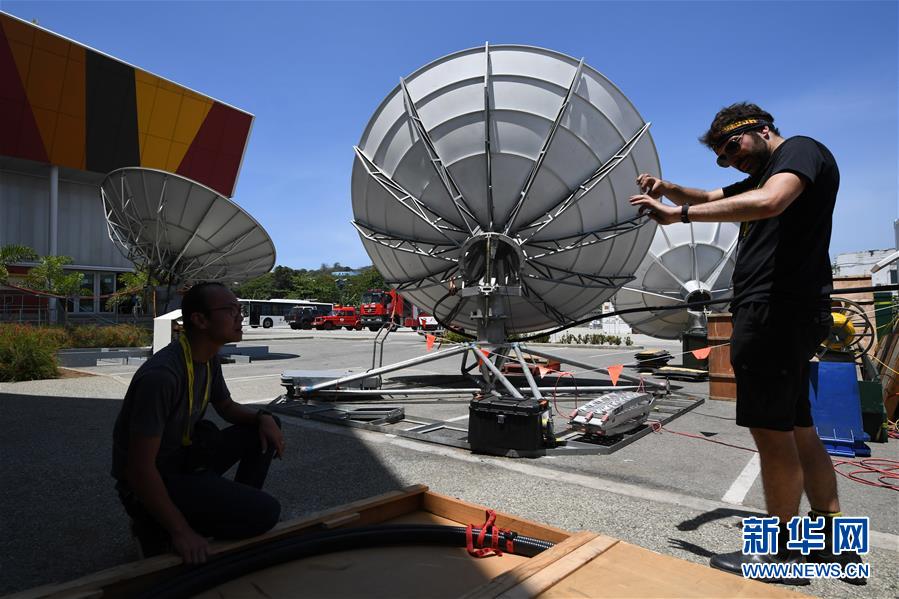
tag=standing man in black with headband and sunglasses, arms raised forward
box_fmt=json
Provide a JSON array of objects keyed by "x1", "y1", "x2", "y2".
[{"x1": 630, "y1": 103, "x2": 860, "y2": 584}]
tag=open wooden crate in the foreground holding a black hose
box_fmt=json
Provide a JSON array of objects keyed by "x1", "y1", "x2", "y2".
[{"x1": 15, "y1": 485, "x2": 802, "y2": 599}]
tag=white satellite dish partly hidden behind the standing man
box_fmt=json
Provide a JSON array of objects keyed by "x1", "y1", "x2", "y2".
[{"x1": 614, "y1": 223, "x2": 740, "y2": 339}]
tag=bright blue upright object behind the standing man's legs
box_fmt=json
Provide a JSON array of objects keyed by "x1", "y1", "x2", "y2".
[{"x1": 809, "y1": 362, "x2": 871, "y2": 458}]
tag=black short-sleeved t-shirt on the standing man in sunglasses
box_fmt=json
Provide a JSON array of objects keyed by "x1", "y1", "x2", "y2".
[{"x1": 724, "y1": 136, "x2": 840, "y2": 311}]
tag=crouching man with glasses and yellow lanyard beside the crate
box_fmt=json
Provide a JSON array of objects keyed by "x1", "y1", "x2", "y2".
[{"x1": 112, "y1": 283, "x2": 284, "y2": 564}]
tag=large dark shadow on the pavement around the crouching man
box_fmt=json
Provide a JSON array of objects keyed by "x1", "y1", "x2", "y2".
[{"x1": 0, "y1": 394, "x2": 404, "y2": 594}]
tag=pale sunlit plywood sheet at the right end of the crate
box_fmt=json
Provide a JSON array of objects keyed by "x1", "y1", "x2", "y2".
[{"x1": 539, "y1": 541, "x2": 805, "y2": 599}]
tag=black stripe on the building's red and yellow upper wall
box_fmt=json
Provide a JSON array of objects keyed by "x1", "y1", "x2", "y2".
[{"x1": 85, "y1": 50, "x2": 140, "y2": 173}]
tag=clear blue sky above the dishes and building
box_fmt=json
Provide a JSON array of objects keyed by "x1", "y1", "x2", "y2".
[{"x1": 0, "y1": 0, "x2": 899, "y2": 268}]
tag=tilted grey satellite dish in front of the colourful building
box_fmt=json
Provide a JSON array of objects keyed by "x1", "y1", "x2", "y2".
[{"x1": 100, "y1": 167, "x2": 275, "y2": 284}]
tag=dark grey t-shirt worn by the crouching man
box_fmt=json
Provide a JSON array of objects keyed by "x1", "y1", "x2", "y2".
[{"x1": 112, "y1": 339, "x2": 231, "y2": 481}]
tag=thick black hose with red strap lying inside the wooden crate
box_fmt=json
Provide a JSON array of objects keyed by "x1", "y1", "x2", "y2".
[{"x1": 138, "y1": 524, "x2": 554, "y2": 599}]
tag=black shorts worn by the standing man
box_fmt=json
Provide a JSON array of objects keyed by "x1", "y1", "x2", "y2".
[{"x1": 730, "y1": 302, "x2": 833, "y2": 431}]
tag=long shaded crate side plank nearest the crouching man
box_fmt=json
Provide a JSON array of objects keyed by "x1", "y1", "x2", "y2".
[{"x1": 14, "y1": 485, "x2": 428, "y2": 599}]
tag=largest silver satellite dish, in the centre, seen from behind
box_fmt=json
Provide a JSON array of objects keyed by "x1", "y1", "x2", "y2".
[{"x1": 352, "y1": 45, "x2": 660, "y2": 334}]
